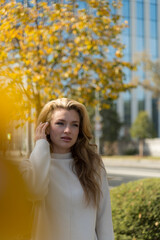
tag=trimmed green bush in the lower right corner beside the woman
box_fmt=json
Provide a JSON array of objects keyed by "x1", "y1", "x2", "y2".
[{"x1": 111, "y1": 178, "x2": 160, "y2": 240}]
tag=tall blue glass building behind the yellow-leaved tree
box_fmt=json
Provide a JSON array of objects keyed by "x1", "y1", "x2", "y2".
[{"x1": 116, "y1": 0, "x2": 160, "y2": 137}]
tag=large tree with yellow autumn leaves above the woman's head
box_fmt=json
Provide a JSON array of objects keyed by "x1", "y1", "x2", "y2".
[{"x1": 0, "y1": 0, "x2": 134, "y2": 122}]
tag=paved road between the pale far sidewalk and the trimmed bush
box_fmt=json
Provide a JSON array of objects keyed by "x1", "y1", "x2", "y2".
[{"x1": 105, "y1": 164, "x2": 160, "y2": 188}]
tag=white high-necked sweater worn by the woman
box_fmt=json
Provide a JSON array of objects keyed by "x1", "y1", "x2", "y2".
[{"x1": 22, "y1": 139, "x2": 114, "y2": 240}]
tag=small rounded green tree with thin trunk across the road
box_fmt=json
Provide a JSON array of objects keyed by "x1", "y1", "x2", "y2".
[{"x1": 130, "y1": 111, "x2": 155, "y2": 156}]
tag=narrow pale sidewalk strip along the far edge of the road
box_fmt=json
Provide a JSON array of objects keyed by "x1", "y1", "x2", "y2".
[{"x1": 102, "y1": 157, "x2": 160, "y2": 171}]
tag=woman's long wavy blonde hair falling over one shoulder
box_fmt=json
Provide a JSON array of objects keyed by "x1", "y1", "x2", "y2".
[{"x1": 37, "y1": 98, "x2": 104, "y2": 206}]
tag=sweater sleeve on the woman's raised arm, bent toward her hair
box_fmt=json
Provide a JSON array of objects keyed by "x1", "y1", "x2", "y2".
[{"x1": 20, "y1": 139, "x2": 51, "y2": 201}]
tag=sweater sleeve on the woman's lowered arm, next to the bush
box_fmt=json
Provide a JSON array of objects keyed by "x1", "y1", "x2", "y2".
[{"x1": 96, "y1": 167, "x2": 114, "y2": 240}]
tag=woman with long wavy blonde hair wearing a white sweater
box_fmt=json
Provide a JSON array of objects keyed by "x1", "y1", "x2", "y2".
[{"x1": 21, "y1": 98, "x2": 114, "y2": 240}]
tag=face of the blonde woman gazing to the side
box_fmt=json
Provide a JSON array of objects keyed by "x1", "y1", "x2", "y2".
[{"x1": 48, "y1": 108, "x2": 80, "y2": 153}]
